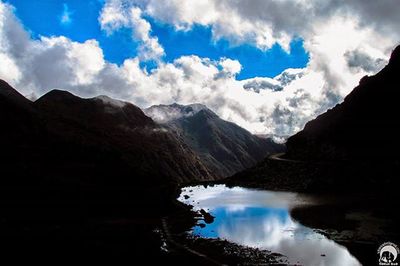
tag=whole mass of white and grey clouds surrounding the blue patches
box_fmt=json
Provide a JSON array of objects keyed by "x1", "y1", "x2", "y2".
[{"x1": 0, "y1": 0, "x2": 400, "y2": 136}]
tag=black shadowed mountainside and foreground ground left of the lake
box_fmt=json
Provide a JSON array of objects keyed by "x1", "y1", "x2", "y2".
[{"x1": 0, "y1": 81, "x2": 213, "y2": 264}]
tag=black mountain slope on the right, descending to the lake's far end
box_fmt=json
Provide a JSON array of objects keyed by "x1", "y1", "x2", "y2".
[{"x1": 229, "y1": 46, "x2": 400, "y2": 193}]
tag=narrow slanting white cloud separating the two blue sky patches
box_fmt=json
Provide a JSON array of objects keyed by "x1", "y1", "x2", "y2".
[{"x1": 99, "y1": 0, "x2": 165, "y2": 61}]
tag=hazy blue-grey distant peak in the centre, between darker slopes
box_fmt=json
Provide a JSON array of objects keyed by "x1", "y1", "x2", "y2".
[{"x1": 145, "y1": 104, "x2": 283, "y2": 177}]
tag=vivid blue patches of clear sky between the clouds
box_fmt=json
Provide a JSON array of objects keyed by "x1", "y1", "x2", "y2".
[{"x1": 8, "y1": 0, "x2": 309, "y2": 79}]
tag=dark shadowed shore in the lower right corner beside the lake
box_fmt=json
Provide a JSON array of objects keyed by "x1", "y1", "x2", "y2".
[{"x1": 291, "y1": 194, "x2": 400, "y2": 265}]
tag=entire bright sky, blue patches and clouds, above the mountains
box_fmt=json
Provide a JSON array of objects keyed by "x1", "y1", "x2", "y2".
[{"x1": 0, "y1": 0, "x2": 400, "y2": 138}]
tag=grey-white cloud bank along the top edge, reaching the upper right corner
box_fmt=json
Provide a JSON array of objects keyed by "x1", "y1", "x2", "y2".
[{"x1": 126, "y1": 0, "x2": 400, "y2": 49}]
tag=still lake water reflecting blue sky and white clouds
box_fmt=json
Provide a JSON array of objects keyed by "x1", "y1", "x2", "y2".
[{"x1": 178, "y1": 185, "x2": 361, "y2": 266}]
